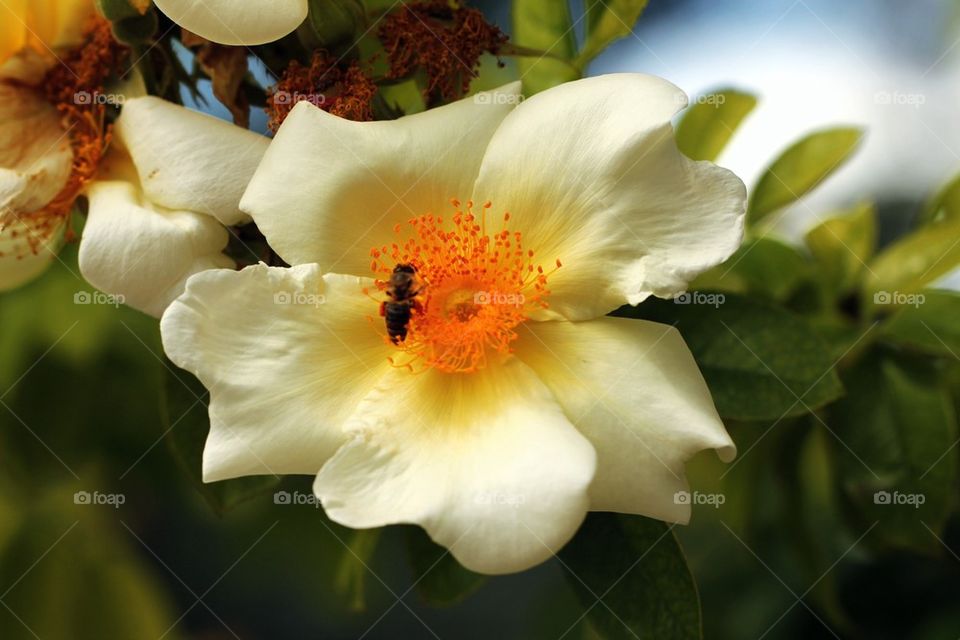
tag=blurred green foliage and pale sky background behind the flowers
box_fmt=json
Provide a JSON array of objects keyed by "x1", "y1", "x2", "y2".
[{"x1": 0, "y1": 0, "x2": 960, "y2": 640}]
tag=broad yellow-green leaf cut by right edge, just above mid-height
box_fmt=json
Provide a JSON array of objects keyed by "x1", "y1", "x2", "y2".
[{"x1": 862, "y1": 218, "x2": 960, "y2": 310}]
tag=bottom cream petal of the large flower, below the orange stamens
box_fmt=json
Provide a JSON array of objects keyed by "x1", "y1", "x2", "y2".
[{"x1": 314, "y1": 359, "x2": 595, "y2": 573}]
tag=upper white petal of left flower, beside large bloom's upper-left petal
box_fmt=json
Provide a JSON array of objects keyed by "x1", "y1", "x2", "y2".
[{"x1": 117, "y1": 97, "x2": 270, "y2": 226}]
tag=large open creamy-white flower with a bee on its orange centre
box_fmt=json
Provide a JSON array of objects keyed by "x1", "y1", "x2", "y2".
[{"x1": 161, "y1": 74, "x2": 745, "y2": 573}]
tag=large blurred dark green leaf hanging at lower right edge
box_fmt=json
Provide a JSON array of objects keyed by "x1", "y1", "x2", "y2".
[{"x1": 827, "y1": 350, "x2": 958, "y2": 550}]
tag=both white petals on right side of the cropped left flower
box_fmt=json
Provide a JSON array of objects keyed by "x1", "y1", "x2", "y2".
[{"x1": 80, "y1": 97, "x2": 269, "y2": 317}]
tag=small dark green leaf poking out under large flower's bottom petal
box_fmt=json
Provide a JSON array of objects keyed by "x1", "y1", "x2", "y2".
[{"x1": 406, "y1": 527, "x2": 487, "y2": 606}]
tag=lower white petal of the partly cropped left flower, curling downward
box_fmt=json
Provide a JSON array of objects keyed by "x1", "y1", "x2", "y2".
[{"x1": 80, "y1": 154, "x2": 234, "y2": 318}]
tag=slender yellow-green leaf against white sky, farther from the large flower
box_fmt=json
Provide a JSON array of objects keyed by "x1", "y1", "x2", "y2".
[{"x1": 747, "y1": 127, "x2": 863, "y2": 224}]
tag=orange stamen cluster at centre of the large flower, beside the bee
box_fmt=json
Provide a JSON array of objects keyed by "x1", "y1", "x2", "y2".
[{"x1": 370, "y1": 200, "x2": 560, "y2": 373}]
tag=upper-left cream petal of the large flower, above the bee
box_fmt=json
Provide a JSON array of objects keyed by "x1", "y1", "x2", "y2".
[{"x1": 241, "y1": 82, "x2": 520, "y2": 275}]
